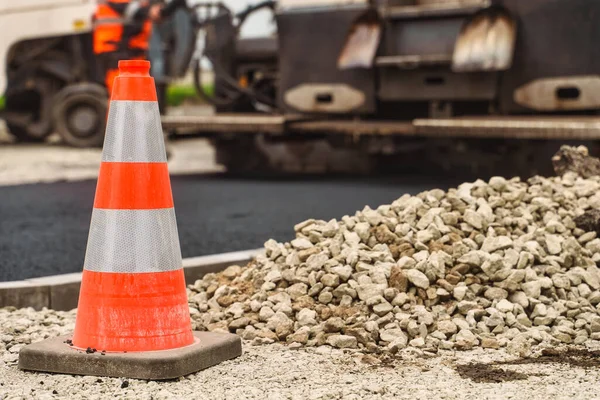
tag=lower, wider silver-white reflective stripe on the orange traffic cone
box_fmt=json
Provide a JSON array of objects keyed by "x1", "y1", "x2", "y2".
[{"x1": 84, "y1": 208, "x2": 183, "y2": 273}]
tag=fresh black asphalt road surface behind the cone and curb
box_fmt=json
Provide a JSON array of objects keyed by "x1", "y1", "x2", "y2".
[{"x1": 0, "y1": 175, "x2": 459, "y2": 281}]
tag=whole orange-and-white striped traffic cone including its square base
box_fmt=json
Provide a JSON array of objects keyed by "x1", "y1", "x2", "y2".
[{"x1": 19, "y1": 60, "x2": 241, "y2": 379}]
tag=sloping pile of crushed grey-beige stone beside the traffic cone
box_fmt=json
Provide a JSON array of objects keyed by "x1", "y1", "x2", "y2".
[{"x1": 188, "y1": 149, "x2": 600, "y2": 356}]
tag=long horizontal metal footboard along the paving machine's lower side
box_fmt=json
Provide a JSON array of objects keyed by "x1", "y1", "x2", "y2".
[{"x1": 163, "y1": 115, "x2": 600, "y2": 140}]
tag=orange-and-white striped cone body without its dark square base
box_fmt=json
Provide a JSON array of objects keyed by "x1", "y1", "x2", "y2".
[{"x1": 73, "y1": 61, "x2": 194, "y2": 351}]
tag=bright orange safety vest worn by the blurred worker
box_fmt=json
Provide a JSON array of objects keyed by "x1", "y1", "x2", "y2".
[{"x1": 94, "y1": 0, "x2": 152, "y2": 54}]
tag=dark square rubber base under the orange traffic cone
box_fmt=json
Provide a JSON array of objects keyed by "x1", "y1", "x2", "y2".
[{"x1": 19, "y1": 332, "x2": 242, "y2": 380}]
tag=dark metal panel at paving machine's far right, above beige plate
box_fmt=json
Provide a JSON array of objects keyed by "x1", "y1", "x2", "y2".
[{"x1": 500, "y1": 0, "x2": 600, "y2": 113}]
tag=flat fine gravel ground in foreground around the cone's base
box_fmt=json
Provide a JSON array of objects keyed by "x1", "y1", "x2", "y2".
[{"x1": 0, "y1": 309, "x2": 600, "y2": 400}]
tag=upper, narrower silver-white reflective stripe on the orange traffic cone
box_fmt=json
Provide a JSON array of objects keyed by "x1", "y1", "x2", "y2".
[{"x1": 102, "y1": 100, "x2": 167, "y2": 162}]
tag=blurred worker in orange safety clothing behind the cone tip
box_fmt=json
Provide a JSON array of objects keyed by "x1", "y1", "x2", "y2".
[{"x1": 93, "y1": 0, "x2": 161, "y2": 96}]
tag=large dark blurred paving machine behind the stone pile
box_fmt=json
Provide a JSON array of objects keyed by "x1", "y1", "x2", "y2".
[{"x1": 163, "y1": 0, "x2": 600, "y2": 175}]
